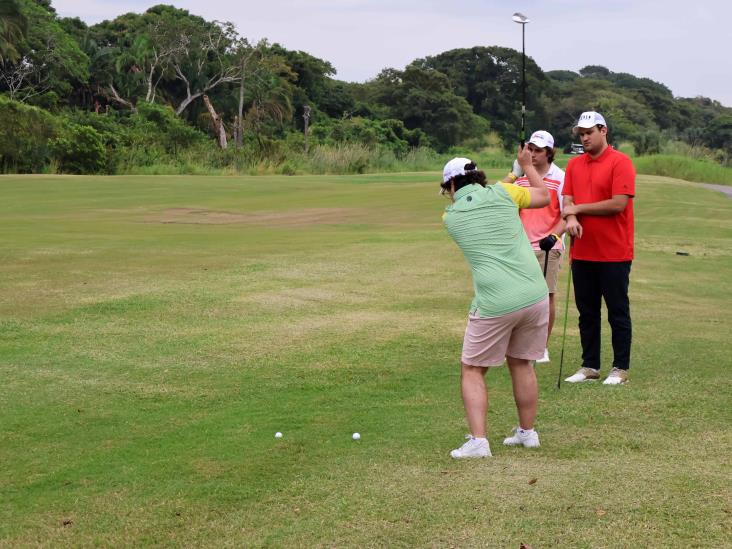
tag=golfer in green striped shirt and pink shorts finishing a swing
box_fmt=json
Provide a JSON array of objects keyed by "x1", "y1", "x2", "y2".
[{"x1": 441, "y1": 147, "x2": 549, "y2": 459}]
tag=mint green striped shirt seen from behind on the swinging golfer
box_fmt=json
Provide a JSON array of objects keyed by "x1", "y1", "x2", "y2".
[{"x1": 443, "y1": 184, "x2": 548, "y2": 317}]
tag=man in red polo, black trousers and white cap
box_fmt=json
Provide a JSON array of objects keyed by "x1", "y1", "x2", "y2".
[{"x1": 562, "y1": 111, "x2": 635, "y2": 385}]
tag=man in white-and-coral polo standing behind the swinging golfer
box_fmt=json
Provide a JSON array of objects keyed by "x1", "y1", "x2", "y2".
[{"x1": 504, "y1": 130, "x2": 566, "y2": 363}]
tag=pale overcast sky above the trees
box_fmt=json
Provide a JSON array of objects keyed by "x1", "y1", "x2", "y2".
[{"x1": 52, "y1": 0, "x2": 732, "y2": 107}]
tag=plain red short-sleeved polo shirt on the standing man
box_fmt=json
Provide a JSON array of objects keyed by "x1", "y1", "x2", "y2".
[{"x1": 564, "y1": 146, "x2": 635, "y2": 261}]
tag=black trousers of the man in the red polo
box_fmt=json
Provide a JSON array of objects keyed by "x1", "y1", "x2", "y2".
[{"x1": 572, "y1": 260, "x2": 632, "y2": 370}]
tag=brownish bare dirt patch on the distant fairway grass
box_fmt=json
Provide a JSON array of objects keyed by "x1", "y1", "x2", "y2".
[{"x1": 148, "y1": 208, "x2": 368, "y2": 227}]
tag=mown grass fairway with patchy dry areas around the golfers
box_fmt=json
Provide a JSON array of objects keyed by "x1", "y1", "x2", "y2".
[{"x1": 0, "y1": 171, "x2": 732, "y2": 548}]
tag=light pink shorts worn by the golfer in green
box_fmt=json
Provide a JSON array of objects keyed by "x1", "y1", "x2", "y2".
[{"x1": 460, "y1": 297, "x2": 549, "y2": 367}]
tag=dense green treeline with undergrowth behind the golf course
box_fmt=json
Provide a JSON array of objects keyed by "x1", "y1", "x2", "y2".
[{"x1": 0, "y1": 0, "x2": 732, "y2": 173}]
